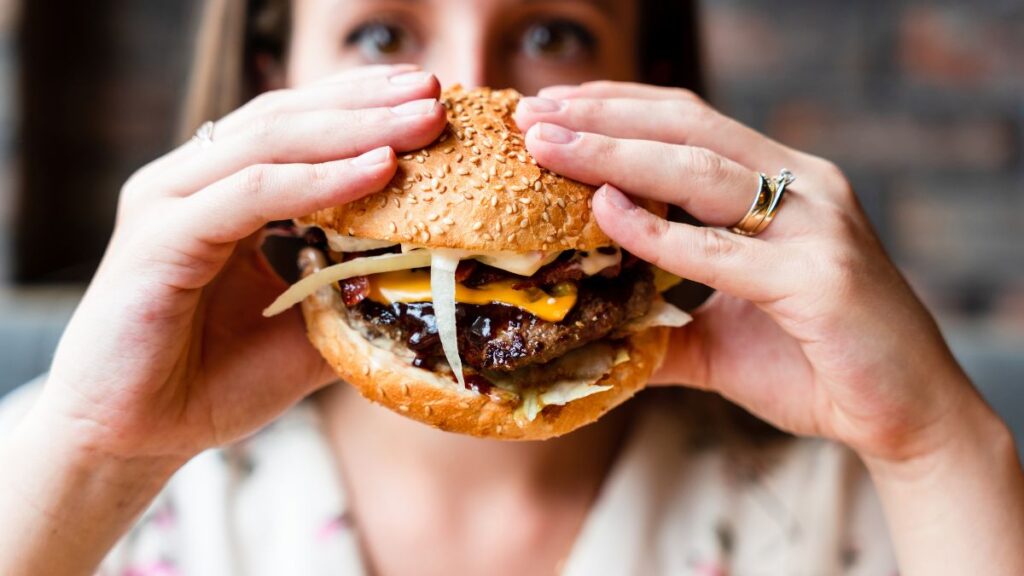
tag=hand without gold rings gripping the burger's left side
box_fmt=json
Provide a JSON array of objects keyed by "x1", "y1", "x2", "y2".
[{"x1": 36, "y1": 67, "x2": 444, "y2": 461}]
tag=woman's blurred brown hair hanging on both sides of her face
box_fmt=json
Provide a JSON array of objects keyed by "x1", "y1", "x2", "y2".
[{"x1": 180, "y1": 0, "x2": 705, "y2": 136}]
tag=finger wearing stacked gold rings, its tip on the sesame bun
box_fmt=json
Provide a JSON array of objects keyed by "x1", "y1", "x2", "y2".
[{"x1": 526, "y1": 124, "x2": 759, "y2": 225}]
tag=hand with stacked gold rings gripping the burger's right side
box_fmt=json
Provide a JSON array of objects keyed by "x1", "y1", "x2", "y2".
[{"x1": 516, "y1": 82, "x2": 990, "y2": 460}]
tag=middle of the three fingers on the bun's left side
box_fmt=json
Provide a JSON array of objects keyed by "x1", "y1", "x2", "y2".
[{"x1": 149, "y1": 98, "x2": 445, "y2": 200}]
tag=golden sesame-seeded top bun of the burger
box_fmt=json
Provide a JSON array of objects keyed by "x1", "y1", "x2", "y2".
[{"x1": 302, "y1": 85, "x2": 612, "y2": 251}]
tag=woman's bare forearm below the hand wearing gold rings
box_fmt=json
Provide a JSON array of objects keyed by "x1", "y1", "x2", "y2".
[{"x1": 864, "y1": 389, "x2": 1024, "y2": 576}]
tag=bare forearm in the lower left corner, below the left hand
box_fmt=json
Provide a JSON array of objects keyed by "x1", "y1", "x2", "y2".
[{"x1": 0, "y1": 401, "x2": 176, "y2": 576}]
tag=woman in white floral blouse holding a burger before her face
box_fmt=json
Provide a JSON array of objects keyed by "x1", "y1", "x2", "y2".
[{"x1": 0, "y1": 0, "x2": 1024, "y2": 575}]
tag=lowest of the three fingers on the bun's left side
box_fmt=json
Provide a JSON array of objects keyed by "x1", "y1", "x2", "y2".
[{"x1": 176, "y1": 148, "x2": 397, "y2": 244}]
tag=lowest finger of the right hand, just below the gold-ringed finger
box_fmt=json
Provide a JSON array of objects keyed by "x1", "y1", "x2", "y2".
[{"x1": 593, "y1": 186, "x2": 786, "y2": 302}]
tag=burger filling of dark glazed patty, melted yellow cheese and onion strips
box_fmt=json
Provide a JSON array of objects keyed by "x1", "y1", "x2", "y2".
[{"x1": 264, "y1": 227, "x2": 688, "y2": 420}]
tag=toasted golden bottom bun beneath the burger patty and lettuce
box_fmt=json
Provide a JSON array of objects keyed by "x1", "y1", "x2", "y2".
[{"x1": 302, "y1": 280, "x2": 670, "y2": 440}]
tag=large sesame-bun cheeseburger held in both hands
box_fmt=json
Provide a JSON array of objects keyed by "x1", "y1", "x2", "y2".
[{"x1": 264, "y1": 86, "x2": 689, "y2": 440}]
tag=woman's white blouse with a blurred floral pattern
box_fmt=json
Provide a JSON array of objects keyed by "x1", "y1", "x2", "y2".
[{"x1": 0, "y1": 381, "x2": 897, "y2": 576}]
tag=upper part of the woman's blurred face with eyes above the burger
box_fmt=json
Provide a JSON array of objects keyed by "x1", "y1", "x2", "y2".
[{"x1": 288, "y1": 0, "x2": 637, "y2": 94}]
